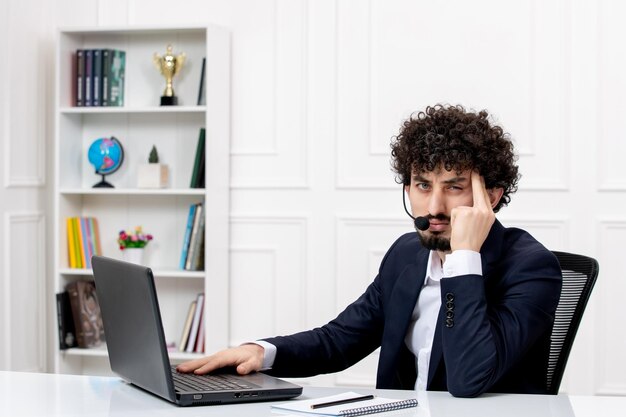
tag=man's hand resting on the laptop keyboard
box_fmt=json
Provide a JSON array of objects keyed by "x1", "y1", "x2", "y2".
[{"x1": 176, "y1": 343, "x2": 265, "y2": 375}]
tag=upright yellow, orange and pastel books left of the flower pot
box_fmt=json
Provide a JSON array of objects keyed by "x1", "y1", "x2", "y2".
[{"x1": 65, "y1": 217, "x2": 102, "y2": 269}]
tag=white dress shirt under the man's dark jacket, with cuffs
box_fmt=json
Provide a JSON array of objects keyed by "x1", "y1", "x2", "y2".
[{"x1": 252, "y1": 250, "x2": 482, "y2": 390}]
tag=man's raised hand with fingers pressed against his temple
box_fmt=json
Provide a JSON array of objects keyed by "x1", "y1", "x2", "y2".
[{"x1": 450, "y1": 171, "x2": 496, "y2": 252}]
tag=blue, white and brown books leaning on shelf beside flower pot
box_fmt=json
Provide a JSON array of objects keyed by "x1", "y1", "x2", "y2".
[{"x1": 179, "y1": 203, "x2": 205, "y2": 271}]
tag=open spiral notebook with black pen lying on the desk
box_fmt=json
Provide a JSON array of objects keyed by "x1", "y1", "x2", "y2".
[{"x1": 271, "y1": 392, "x2": 417, "y2": 417}]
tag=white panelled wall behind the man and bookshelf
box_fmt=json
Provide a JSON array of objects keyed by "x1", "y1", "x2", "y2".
[{"x1": 0, "y1": 0, "x2": 626, "y2": 395}]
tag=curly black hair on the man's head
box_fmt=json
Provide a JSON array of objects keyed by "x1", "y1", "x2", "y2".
[{"x1": 391, "y1": 104, "x2": 520, "y2": 212}]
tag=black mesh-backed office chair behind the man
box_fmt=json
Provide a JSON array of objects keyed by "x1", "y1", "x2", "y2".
[{"x1": 547, "y1": 251, "x2": 599, "y2": 394}]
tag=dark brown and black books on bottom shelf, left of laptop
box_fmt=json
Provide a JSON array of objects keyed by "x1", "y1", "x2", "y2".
[{"x1": 56, "y1": 281, "x2": 104, "y2": 350}]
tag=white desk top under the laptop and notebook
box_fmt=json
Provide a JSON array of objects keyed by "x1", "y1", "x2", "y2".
[{"x1": 0, "y1": 372, "x2": 626, "y2": 417}]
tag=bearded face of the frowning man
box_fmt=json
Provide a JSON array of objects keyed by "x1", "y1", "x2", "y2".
[{"x1": 405, "y1": 169, "x2": 474, "y2": 252}]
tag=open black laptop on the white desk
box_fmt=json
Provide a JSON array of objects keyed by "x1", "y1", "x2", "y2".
[{"x1": 92, "y1": 256, "x2": 302, "y2": 406}]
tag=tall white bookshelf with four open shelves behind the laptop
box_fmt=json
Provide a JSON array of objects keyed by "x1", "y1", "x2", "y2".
[{"x1": 50, "y1": 26, "x2": 230, "y2": 374}]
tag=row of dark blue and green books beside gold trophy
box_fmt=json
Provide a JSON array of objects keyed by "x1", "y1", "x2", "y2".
[{"x1": 74, "y1": 49, "x2": 126, "y2": 107}]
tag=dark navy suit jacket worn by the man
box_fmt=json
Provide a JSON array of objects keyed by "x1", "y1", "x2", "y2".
[{"x1": 265, "y1": 220, "x2": 562, "y2": 397}]
